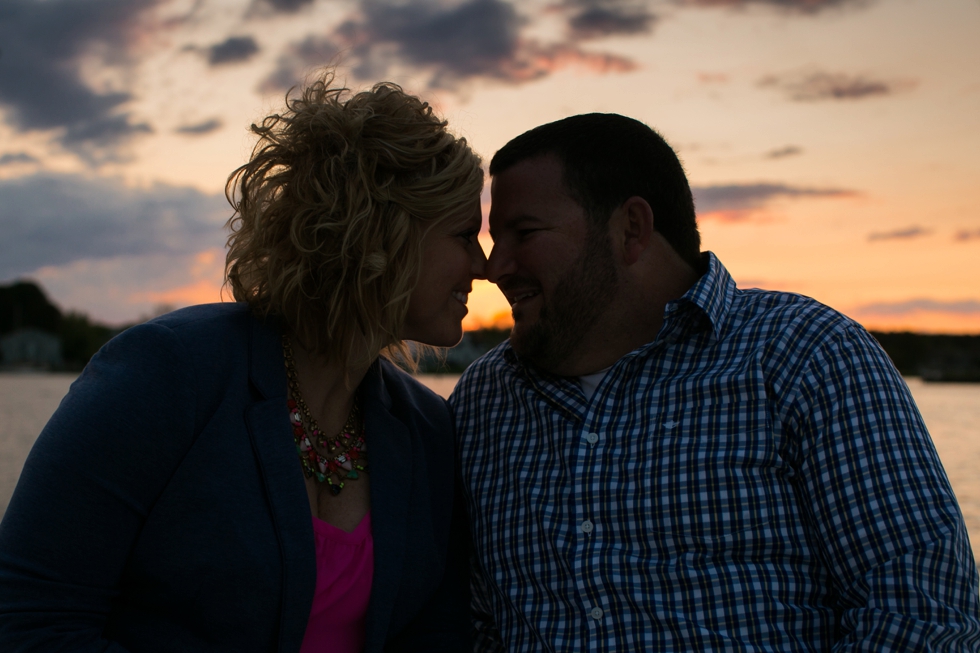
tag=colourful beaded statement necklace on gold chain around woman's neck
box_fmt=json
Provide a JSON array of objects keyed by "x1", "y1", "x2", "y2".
[{"x1": 282, "y1": 334, "x2": 368, "y2": 496}]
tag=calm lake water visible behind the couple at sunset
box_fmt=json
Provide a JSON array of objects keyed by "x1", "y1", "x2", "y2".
[{"x1": 0, "y1": 374, "x2": 980, "y2": 561}]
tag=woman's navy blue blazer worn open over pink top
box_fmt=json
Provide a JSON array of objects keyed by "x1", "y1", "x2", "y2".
[{"x1": 0, "y1": 304, "x2": 472, "y2": 653}]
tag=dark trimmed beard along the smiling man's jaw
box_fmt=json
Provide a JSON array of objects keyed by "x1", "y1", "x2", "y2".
[{"x1": 510, "y1": 229, "x2": 617, "y2": 371}]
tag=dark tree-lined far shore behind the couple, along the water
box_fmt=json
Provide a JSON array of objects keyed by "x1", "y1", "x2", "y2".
[{"x1": 0, "y1": 281, "x2": 980, "y2": 382}]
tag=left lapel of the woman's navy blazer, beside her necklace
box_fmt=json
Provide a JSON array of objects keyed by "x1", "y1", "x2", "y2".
[{"x1": 246, "y1": 320, "x2": 316, "y2": 652}]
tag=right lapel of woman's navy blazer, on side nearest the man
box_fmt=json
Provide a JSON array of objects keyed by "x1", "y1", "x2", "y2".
[{"x1": 359, "y1": 362, "x2": 412, "y2": 652}]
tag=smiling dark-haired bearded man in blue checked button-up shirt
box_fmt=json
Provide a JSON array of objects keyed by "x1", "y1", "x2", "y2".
[{"x1": 451, "y1": 114, "x2": 980, "y2": 652}]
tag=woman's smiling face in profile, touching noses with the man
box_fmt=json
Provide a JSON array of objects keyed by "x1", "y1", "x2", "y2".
[{"x1": 402, "y1": 198, "x2": 487, "y2": 347}]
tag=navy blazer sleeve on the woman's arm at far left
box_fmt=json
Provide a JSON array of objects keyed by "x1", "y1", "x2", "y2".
[{"x1": 0, "y1": 324, "x2": 194, "y2": 653}]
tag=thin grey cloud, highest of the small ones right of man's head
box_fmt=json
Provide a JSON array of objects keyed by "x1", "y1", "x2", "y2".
[{"x1": 759, "y1": 71, "x2": 915, "y2": 102}]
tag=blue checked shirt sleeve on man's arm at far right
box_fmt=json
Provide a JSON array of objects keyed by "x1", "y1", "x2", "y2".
[{"x1": 793, "y1": 326, "x2": 980, "y2": 651}]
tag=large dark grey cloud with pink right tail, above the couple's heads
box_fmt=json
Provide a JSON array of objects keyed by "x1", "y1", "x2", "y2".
[{"x1": 260, "y1": 0, "x2": 635, "y2": 91}]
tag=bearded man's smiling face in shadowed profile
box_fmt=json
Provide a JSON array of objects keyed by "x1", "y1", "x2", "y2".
[{"x1": 487, "y1": 150, "x2": 617, "y2": 370}]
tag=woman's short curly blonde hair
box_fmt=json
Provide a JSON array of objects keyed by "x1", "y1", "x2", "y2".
[{"x1": 225, "y1": 71, "x2": 483, "y2": 368}]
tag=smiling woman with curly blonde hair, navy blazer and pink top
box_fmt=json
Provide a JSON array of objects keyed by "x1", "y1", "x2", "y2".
[{"x1": 0, "y1": 75, "x2": 486, "y2": 653}]
